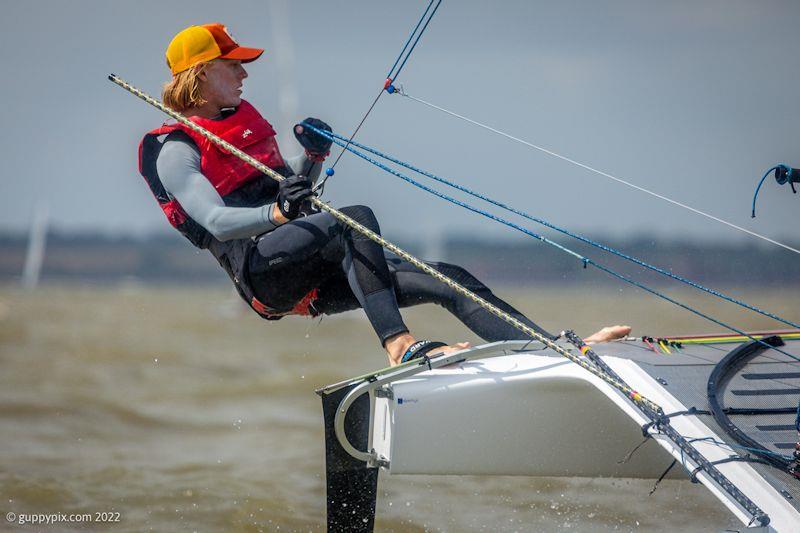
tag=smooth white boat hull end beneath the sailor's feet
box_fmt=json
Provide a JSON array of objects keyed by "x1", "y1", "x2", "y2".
[{"x1": 373, "y1": 355, "x2": 668, "y2": 478}]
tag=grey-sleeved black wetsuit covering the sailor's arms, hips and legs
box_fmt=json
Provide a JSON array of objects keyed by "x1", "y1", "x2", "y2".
[{"x1": 156, "y1": 124, "x2": 552, "y2": 343}]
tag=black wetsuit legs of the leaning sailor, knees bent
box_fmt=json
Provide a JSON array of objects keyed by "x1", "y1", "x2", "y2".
[{"x1": 248, "y1": 206, "x2": 553, "y2": 343}]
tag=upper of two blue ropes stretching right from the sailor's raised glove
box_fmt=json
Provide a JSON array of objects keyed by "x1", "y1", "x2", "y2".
[{"x1": 306, "y1": 125, "x2": 800, "y2": 329}]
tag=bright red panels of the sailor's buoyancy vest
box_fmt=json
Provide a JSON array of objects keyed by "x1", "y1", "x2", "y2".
[{"x1": 139, "y1": 100, "x2": 285, "y2": 244}]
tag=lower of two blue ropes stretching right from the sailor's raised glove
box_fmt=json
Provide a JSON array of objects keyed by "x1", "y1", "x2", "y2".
[{"x1": 308, "y1": 125, "x2": 800, "y2": 361}]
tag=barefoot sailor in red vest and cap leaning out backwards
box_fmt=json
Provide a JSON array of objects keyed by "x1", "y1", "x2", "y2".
[{"x1": 139, "y1": 23, "x2": 630, "y2": 365}]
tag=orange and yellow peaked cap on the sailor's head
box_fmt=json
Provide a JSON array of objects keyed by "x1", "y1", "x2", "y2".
[{"x1": 167, "y1": 23, "x2": 264, "y2": 76}]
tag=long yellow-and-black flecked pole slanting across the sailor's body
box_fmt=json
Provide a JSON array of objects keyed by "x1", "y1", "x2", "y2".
[{"x1": 108, "y1": 74, "x2": 663, "y2": 413}]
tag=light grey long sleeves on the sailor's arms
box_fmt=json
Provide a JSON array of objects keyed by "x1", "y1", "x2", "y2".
[{"x1": 156, "y1": 141, "x2": 322, "y2": 241}]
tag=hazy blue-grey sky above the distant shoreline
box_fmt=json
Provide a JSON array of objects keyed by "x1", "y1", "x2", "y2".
[{"x1": 0, "y1": 0, "x2": 800, "y2": 242}]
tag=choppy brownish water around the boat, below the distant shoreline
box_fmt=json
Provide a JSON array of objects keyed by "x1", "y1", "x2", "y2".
[{"x1": 0, "y1": 286, "x2": 800, "y2": 531}]
